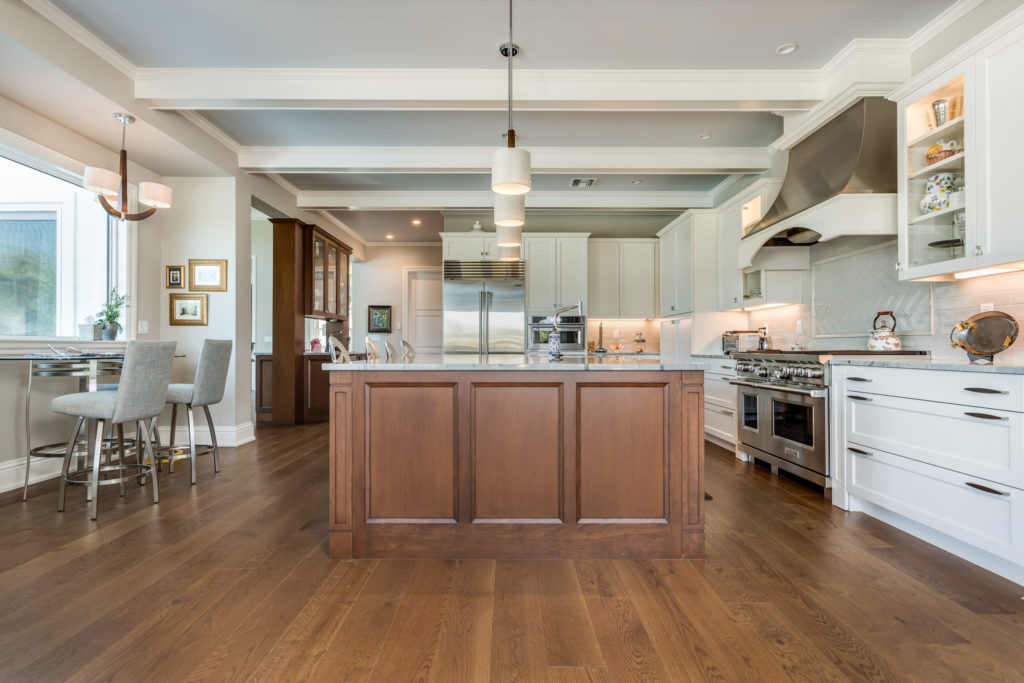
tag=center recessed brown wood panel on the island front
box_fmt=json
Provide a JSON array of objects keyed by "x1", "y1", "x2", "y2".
[{"x1": 470, "y1": 384, "x2": 562, "y2": 523}]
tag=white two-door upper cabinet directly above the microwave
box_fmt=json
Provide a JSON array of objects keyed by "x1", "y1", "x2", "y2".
[{"x1": 522, "y1": 233, "x2": 588, "y2": 314}]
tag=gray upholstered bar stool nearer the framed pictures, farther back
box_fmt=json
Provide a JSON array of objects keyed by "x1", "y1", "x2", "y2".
[{"x1": 157, "y1": 339, "x2": 231, "y2": 483}]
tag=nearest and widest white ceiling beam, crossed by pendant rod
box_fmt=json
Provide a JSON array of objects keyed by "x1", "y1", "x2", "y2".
[{"x1": 135, "y1": 68, "x2": 823, "y2": 111}]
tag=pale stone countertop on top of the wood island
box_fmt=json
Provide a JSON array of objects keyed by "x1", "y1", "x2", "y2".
[{"x1": 323, "y1": 353, "x2": 708, "y2": 371}]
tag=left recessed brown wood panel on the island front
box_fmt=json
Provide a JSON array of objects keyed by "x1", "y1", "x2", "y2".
[{"x1": 366, "y1": 382, "x2": 458, "y2": 522}]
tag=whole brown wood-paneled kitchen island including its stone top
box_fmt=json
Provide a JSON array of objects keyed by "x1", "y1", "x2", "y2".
[{"x1": 325, "y1": 355, "x2": 705, "y2": 558}]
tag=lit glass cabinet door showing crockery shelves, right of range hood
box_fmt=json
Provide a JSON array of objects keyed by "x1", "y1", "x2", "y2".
[{"x1": 903, "y1": 75, "x2": 973, "y2": 268}]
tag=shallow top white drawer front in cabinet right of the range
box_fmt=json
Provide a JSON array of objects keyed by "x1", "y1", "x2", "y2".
[{"x1": 844, "y1": 366, "x2": 1024, "y2": 413}]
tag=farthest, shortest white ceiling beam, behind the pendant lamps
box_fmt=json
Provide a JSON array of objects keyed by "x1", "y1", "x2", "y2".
[{"x1": 297, "y1": 189, "x2": 712, "y2": 210}]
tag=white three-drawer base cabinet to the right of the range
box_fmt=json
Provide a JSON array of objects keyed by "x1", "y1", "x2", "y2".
[{"x1": 830, "y1": 365, "x2": 1024, "y2": 581}]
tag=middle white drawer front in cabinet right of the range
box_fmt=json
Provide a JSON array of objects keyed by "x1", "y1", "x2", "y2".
[{"x1": 844, "y1": 391, "x2": 1024, "y2": 488}]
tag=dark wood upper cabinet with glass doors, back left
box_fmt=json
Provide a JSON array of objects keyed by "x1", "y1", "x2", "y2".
[{"x1": 303, "y1": 225, "x2": 351, "y2": 321}]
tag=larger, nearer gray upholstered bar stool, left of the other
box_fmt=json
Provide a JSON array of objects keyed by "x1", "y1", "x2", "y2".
[{"x1": 50, "y1": 341, "x2": 175, "y2": 519}]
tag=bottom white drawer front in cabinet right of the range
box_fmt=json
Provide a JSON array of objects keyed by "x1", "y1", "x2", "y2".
[{"x1": 847, "y1": 446, "x2": 1024, "y2": 563}]
